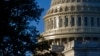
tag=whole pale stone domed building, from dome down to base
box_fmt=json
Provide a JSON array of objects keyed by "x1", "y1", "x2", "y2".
[{"x1": 42, "y1": 0, "x2": 100, "y2": 56}]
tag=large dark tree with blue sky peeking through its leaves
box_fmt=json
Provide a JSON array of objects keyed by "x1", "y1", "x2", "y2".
[{"x1": 0, "y1": 0, "x2": 43, "y2": 56}]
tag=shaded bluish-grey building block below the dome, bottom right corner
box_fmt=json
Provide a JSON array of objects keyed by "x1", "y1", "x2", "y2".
[{"x1": 73, "y1": 39, "x2": 100, "y2": 56}]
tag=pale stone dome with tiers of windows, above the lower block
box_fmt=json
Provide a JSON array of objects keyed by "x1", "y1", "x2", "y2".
[{"x1": 43, "y1": 0, "x2": 100, "y2": 38}]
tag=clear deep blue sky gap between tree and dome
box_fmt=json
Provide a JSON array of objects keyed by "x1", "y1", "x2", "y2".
[{"x1": 36, "y1": 0, "x2": 51, "y2": 33}]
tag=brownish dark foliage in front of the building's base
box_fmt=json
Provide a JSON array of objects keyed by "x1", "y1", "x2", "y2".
[{"x1": 35, "y1": 36, "x2": 58, "y2": 56}]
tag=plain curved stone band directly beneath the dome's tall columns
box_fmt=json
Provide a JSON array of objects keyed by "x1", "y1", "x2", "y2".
[{"x1": 43, "y1": 28, "x2": 100, "y2": 35}]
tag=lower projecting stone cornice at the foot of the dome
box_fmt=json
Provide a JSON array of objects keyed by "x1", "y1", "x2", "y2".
[{"x1": 44, "y1": 33, "x2": 100, "y2": 40}]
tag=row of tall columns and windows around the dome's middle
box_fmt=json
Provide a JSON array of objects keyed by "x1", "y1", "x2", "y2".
[{"x1": 45, "y1": 16, "x2": 100, "y2": 30}]
